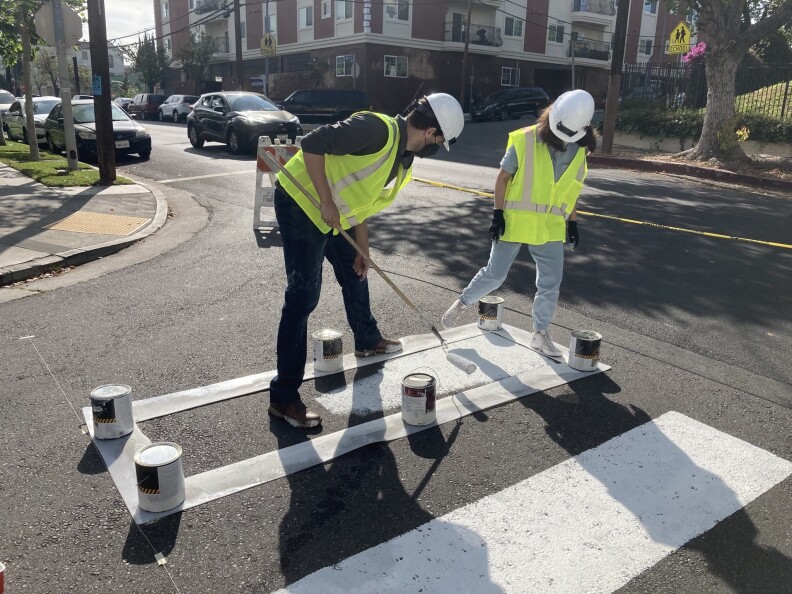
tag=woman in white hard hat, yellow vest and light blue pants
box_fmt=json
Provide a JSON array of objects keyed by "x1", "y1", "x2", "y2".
[{"x1": 442, "y1": 90, "x2": 597, "y2": 357}]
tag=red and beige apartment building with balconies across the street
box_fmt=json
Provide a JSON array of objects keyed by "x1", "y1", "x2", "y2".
[{"x1": 153, "y1": 0, "x2": 700, "y2": 113}]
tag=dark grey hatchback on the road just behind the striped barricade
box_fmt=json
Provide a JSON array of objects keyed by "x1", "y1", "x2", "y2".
[{"x1": 187, "y1": 91, "x2": 303, "y2": 155}]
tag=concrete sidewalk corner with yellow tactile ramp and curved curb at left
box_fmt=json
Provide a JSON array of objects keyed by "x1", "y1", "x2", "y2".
[{"x1": 0, "y1": 163, "x2": 168, "y2": 286}]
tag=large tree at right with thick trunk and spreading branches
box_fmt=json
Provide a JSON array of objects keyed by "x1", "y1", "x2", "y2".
[{"x1": 670, "y1": 0, "x2": 792, "y2": 164}]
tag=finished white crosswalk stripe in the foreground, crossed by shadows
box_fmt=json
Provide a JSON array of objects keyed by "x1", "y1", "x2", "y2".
[{"x1": 279, "y1": 412, "x2": 792, "y2": 594}]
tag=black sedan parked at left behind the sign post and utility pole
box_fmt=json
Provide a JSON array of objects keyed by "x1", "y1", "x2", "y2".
[{"x1": 44, "y1": 99, "x2": 151, "y2": 159}]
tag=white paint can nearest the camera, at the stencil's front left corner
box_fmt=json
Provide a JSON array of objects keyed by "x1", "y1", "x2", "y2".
[{"x1": 135, "y1": 441, "x2": 184, "y2": 512}]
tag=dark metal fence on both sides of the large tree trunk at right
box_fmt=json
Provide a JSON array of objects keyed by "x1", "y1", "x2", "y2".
[{"x1": 619, "y1": 64, "x2": 792, "y2": 120}]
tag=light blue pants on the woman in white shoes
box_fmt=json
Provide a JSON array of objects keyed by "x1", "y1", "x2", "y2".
[{"x1": 459, "y1": 240, "x2": 564, "y2": 330}]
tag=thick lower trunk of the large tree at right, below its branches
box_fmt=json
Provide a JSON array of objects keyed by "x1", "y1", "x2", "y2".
[{"x1": 688, "y1": 51, "x2": 748, "y2": 164}]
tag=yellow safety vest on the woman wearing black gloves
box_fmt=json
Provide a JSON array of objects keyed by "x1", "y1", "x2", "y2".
[{"x1": 501, "y1": 126, "x2": 588, "y2": 245}]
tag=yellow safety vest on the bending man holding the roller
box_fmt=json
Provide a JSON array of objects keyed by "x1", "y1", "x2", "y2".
[{"x1": 278, "y1": 112, "x2": 412, "y2": 233}]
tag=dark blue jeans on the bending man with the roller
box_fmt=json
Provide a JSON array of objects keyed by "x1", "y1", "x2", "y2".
[{"x1": 270, "y1": 188, "x2": 382, "y2": 404}]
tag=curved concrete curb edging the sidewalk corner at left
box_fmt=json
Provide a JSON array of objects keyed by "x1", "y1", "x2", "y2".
[{"x1": 0, "y1": 176, "x2": 168, "y2": 287}]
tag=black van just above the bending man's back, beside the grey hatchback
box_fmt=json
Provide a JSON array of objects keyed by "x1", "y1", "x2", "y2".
[{"x1": 278, "y1": 89, "x2": 371, "y2": 125}]
